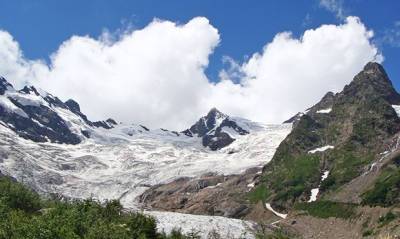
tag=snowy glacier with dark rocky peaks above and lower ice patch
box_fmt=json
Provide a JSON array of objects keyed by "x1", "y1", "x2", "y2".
[{"x1": 0, "y1": 78, "x2": 292, "y2": 238}]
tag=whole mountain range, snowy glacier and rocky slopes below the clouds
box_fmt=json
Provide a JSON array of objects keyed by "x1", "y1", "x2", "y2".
[{"x1": 0, "y1": 63, "x2": 400, "y2": 238}]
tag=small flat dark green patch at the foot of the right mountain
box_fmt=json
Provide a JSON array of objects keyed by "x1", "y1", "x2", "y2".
[{"x1": 294, "y1": 201, "x2": 356, "y2": 219}]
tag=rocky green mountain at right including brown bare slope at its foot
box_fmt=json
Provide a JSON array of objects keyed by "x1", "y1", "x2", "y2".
[{"x1": 141, "y1": 63, "x2": 400, "y2": 238}]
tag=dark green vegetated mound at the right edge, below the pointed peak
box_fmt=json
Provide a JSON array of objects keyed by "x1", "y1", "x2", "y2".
[{"x1": 362, "y1": 167, "x2": 400, "y2": 207}]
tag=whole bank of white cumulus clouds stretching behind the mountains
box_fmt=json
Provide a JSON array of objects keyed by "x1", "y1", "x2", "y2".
[{"x1": 0, "y1": 17, "x2": 382, "y2": 130}]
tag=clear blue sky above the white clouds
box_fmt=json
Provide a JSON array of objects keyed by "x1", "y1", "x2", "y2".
[{"x1": 0, "y1": 0, "x2": 400, "y2": 85}]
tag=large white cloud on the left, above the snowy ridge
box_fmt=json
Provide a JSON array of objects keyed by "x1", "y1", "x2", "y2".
[{"x1": 0, "y1": 17, "x2": 219, "y2": 128}]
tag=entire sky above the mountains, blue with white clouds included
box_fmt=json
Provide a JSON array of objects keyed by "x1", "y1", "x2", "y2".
[{"x1": 0, "y1": 0, "x2": 400, "y2": 130}]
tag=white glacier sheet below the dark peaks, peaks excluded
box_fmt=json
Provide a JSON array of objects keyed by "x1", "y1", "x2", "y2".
[{"x1": 0, "y1": 121, "x2": 291, "y2": 208}]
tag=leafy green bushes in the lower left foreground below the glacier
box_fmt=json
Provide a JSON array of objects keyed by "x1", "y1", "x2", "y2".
[{"x1": 0, "y1": 177, "x2": 198, "y2": 239}]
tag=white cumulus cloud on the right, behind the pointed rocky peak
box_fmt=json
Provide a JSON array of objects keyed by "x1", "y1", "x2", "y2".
[{"x1": 209, "y1": 17, "x2": 382, "y2": 122}]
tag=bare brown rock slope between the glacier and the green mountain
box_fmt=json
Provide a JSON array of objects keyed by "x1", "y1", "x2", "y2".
[{"x1": 140, "y1": 168, "x2": 259, "y2": 218}]
